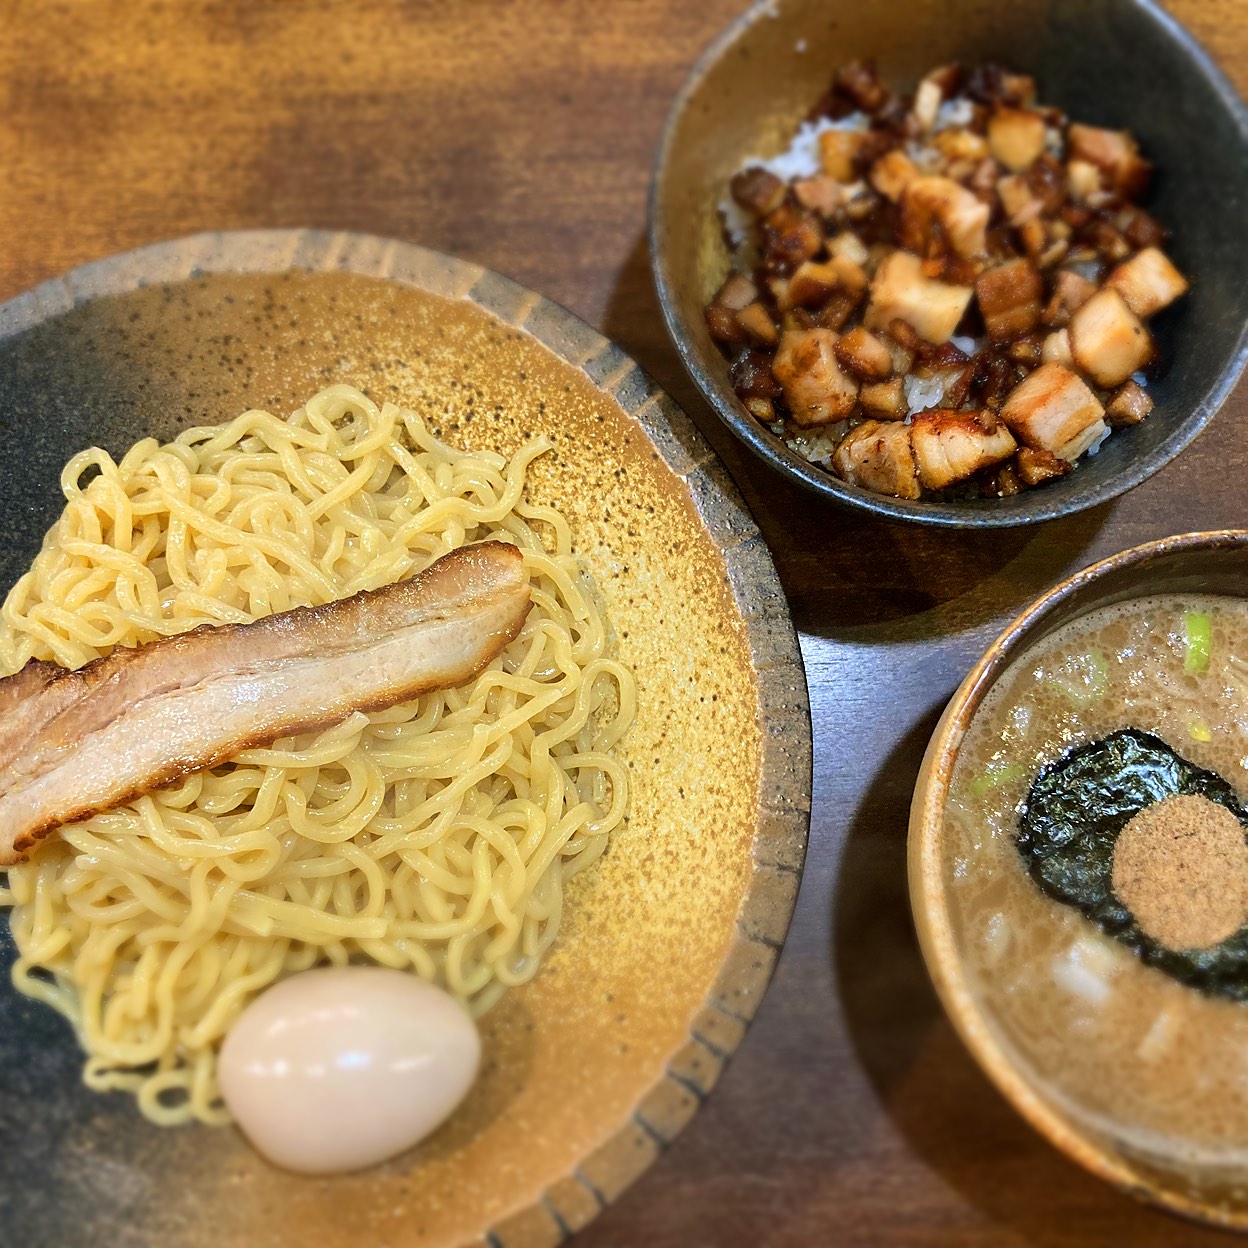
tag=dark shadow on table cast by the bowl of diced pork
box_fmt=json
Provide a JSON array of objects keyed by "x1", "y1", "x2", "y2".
[{"x1": 603, "y1": 237, "x2": 1114, "y2": 641}]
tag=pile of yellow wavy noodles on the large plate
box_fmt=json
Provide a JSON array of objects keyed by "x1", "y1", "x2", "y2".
[{"x1": 0, "y1": 386, "x2": 634, "y2": 1124}]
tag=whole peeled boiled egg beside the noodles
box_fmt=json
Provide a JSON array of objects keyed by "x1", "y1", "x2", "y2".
[{"x1": 218, "y1": 966, "x2": 480, "y2": 1174}]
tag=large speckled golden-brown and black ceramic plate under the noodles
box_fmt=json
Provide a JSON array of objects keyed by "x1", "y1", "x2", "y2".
[{"x1": 0, "y1": 231, "x2": 810, "y2": 1248}]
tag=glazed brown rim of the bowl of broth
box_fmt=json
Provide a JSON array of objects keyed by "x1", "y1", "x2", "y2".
[{"x1": 907, "y1": 529, "x2": 1248, "y2": 1231}]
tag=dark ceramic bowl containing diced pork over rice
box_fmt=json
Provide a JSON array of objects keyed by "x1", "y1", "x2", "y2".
[{"x1": 650, "y1": 0, "x2": 1248, "y2": 528}]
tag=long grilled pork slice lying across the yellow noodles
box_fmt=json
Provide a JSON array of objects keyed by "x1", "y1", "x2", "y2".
[{"x1": 0, "y1": 542, "x2": 529, "y2": 865}]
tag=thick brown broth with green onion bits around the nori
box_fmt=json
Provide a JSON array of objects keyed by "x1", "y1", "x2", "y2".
[{"x1": 943, "y1": 595, "x2": 1248, "y2": 1171}]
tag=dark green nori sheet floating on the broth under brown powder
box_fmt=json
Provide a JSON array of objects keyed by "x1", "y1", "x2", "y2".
[{"x1": 1017, "y1": 728, "x2": 1248, "y2": 1001}]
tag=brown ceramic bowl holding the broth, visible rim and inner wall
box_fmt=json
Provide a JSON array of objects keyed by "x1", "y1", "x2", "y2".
[{"x1": 909, "y1": 529, "x2": 1248, "y2": 1228}]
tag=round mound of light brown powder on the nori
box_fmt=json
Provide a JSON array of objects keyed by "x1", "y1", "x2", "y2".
[{"x1": 1112, "y1": 796, "x2": 1248, "y2": 950}]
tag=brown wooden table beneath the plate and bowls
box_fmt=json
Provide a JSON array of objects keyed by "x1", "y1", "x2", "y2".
[{"x1": 0, "y1": 0, "x2": 1248, "y2": 1248}]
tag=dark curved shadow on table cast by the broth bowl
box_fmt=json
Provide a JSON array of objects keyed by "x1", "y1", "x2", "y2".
[{"x1": 830, "y1": 706, "x2": 1228, "y2": 1248}]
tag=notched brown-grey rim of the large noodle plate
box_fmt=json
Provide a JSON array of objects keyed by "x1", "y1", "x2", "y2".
[{"x1": 0, "y1": 228, "x2": 812, "y2": 1248}]
